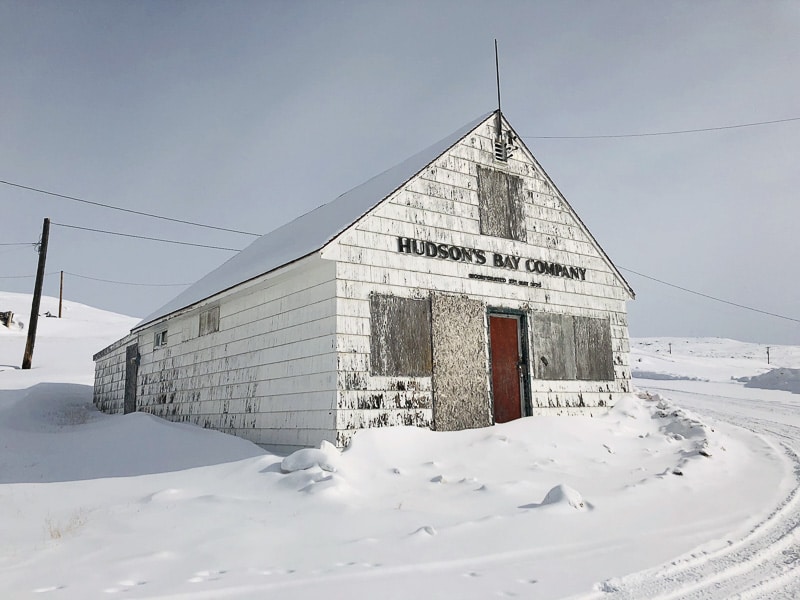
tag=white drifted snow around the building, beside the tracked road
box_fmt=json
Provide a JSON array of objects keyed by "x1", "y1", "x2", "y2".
[{"x1": 0, "y1": 293, "x2": 800, "y2": 599}]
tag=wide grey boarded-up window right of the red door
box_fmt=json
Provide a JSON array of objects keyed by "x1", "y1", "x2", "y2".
[{"x1": 533, "y1": 313, "x2": 614, "y2": 381}]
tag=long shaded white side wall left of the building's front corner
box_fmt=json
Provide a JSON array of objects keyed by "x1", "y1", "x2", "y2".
[{"x1": 132, "y1": 255, "x2": 337, "y2": 450}]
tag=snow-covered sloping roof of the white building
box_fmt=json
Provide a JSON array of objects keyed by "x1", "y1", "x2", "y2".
[{"x1": 136, "y1": 112, "x2": 494, "y2": 329}]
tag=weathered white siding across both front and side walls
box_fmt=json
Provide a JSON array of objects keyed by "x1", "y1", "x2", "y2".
[{"x1": 95, "y1": 111, "x2": 630, "y2": 450}]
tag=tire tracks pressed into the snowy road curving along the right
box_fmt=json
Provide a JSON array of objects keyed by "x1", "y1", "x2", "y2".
[{"x1": 576, "y1": 386, "x2": 800, "y2": 600}]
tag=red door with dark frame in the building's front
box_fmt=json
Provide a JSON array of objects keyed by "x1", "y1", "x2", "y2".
[{"x1": 489, "y1": 315, "x2": 522, "y2": 423}]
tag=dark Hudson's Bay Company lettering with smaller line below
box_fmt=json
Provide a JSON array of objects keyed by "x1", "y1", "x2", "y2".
[{"x1": 397, "y1": 237, "x2": 586, "y2": 287}]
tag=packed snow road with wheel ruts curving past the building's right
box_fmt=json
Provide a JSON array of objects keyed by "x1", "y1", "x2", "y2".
[{"x1": 579, "y1": 380, "x2": 800, "y2": 600}]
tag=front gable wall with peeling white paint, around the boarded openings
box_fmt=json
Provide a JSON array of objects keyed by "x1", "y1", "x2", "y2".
[{"x1": 322, "y1": 115, "x2": 630, "y2": 444}]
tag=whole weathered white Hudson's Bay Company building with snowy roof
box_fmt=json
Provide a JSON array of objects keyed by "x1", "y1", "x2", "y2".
[{"x1": 94, "y1": 111, "x2": 633, "y2": 450}]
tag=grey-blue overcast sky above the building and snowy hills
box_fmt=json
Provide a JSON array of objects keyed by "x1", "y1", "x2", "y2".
[{"x1": 0, "y1": 0, "x2": 800, "y2": 344}]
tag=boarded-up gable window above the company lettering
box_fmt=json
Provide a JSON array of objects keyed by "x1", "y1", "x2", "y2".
[{"x1": 478, "y1": 166, "x2": 526, "y2": 242}]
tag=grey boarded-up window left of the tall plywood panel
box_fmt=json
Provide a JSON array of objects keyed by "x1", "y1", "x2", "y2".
[{"x1": 369, "y1": 294, "x2": 433, "y2": 377}]
